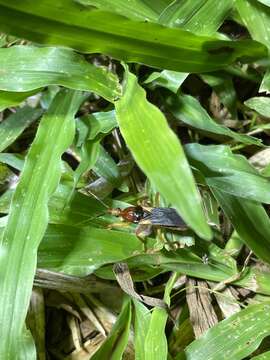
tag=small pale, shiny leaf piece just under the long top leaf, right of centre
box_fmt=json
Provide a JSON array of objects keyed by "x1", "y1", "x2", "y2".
[{"x1": 144, "y1": 70, "x2": 188, "y2": 93}]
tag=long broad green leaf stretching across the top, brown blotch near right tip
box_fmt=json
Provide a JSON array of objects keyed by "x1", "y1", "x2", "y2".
[{"x1": 0, "y1": 0, "x2": 267, "y2": 73}]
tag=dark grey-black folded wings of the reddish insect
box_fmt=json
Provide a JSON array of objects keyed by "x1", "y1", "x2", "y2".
[{"x1": 140, "y1": 208, "x2": 187, "y2": 228}]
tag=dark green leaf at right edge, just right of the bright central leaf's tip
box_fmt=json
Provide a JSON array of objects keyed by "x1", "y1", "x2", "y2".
[{"x1": 212, "y1": 188, "x2": 270, "y2": 263}]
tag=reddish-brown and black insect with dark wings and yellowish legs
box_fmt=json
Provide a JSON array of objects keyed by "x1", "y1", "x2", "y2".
[{"x1": 108, "y1": 206, "x2": 187, "y2": 239}]
